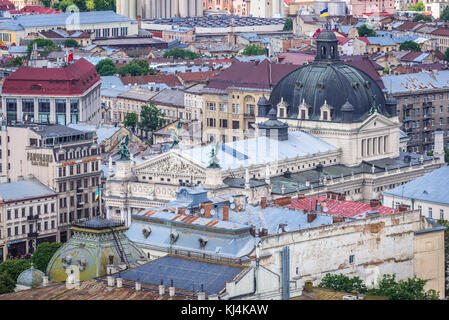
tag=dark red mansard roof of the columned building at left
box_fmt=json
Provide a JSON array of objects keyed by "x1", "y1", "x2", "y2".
[{"x1": 2, "y1": 58, "x2": 101, "y2": 95}]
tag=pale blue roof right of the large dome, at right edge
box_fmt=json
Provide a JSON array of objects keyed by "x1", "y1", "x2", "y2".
[{"x1": 382, "y1": 70, "x2": 449, "y2": 94}]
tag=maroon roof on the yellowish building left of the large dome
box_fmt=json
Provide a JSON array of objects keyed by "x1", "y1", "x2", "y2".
[{"x1": 206, "y1": 60, "x2": 300, "y2": 90}]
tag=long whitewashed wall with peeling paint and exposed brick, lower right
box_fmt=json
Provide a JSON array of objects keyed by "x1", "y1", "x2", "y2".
[{"x1": 261, "y1": 211, "x2": 444, "y2": 292}]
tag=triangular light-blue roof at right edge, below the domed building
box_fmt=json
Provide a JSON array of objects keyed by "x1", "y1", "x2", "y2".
[{"x1": 383, "y1": 166, "x2": 449, "y2": 205}]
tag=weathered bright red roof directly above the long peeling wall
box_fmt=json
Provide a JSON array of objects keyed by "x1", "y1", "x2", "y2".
[{"x1": 287, "y1": 196, "x2": 398, "y2": 218}]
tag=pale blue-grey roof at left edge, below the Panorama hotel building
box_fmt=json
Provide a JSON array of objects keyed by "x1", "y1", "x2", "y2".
[{"x1": 0, "y1": 179, "x2": 56, "y2": 202}]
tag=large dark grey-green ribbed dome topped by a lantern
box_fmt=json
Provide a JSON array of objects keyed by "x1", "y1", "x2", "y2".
[{"x1": 270, "y1": 62, "x2": 388, "y2": 122}]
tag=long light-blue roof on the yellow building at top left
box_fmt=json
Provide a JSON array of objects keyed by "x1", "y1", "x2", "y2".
[{"x1": 0, "y1": 11, "x2": 132, "y2": 31}]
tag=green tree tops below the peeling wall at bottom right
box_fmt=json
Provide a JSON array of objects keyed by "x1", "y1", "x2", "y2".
[{"x1": 318, "y1": 273, "x2": 439, "y2": 300}]
